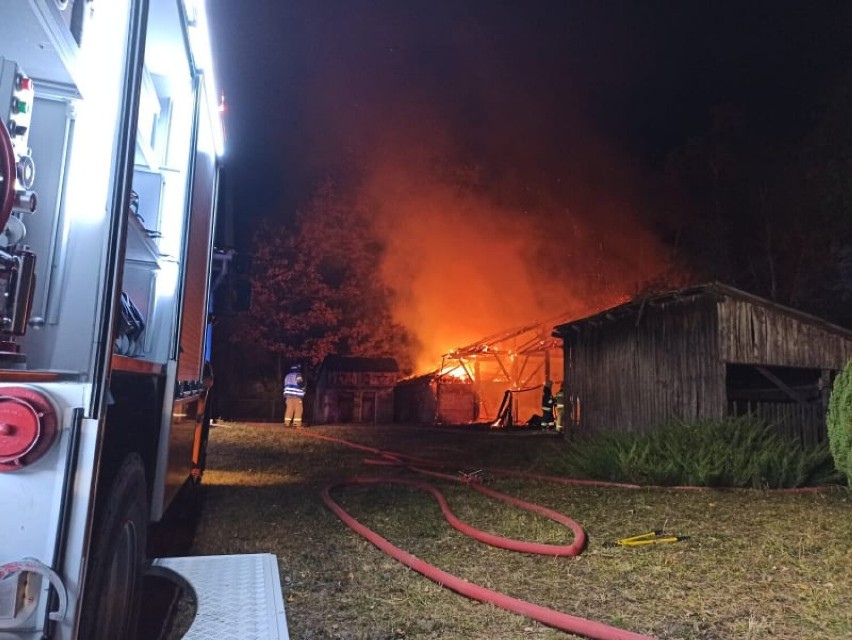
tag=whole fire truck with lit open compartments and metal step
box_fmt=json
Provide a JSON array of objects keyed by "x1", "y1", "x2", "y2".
[{"x1": 0, "y1": 0, "x2": 287, "y2": 640}]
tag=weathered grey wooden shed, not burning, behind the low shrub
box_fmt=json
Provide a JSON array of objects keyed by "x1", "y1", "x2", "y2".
[{"x1": 555, "y1": 283, "x2": 852, "y2": 442}]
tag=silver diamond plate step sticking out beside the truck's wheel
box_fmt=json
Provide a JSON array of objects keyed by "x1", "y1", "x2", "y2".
[{"x1": 152, "y1": 553, "x2": 289, "y2": 640}]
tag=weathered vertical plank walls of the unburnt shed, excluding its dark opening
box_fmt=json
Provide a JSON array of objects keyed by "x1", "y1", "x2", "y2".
[{"x1": 563, "y1": 297, "x2": 852, "y2": 431}]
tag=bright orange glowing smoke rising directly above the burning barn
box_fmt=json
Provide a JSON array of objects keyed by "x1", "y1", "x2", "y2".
[{"x1": 352, "y1": 125, "x2": 663, "y2": 377}]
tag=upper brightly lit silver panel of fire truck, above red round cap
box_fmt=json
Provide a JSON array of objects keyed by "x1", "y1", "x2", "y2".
[{"x1": 0, "y1": 0, "x2": 133, "y2": 374}]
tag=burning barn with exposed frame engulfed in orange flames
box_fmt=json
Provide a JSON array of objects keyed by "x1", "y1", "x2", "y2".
[{"x1": 394, "y1": 316, "x2": 565, "y2": 427}]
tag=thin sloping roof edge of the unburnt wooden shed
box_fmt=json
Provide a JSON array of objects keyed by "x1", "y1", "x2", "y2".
[{"x1": 554, "y1": 282, "x2": 852, "y2": 339}]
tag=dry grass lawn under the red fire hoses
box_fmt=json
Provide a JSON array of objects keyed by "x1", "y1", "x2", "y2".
[{"x1": 186, "y1": 424, "x2": 852, "y2": 640}]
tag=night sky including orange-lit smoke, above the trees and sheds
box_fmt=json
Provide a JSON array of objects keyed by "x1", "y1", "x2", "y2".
[{"x1": 205, "y1": 0, "x2": 852, "y2": 366}]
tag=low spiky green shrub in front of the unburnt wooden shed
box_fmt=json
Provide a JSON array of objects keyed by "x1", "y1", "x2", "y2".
[{"x1": 564, "y1": 416, "x2": 840, "y2": 488}]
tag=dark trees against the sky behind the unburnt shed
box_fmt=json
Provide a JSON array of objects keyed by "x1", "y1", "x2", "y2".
[{"x1": 652, "y1": 75, "x2": 852, "y2": 326}]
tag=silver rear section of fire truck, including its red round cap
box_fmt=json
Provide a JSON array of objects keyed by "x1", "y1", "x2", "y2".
[{"x1": 0, "y1": 0, "x2": 138, "y2": 640}]
